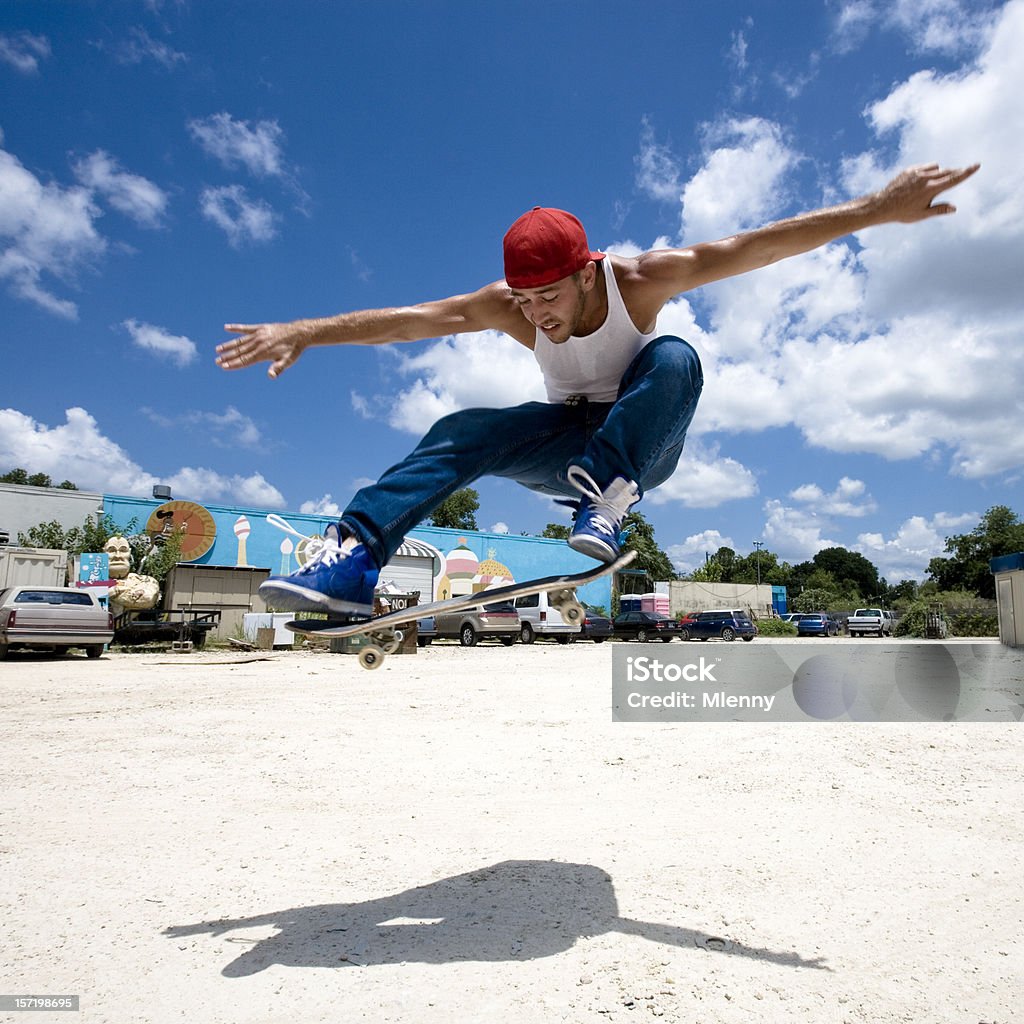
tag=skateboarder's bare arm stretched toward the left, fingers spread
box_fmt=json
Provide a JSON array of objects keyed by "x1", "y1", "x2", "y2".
[{"x1": 217, "y1": 282, "x2": 526, "y2": 378}]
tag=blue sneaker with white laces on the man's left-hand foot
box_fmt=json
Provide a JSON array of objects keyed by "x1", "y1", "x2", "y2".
[{"x1": 259, "y1": 523, "x2": 379, "y2": 617}]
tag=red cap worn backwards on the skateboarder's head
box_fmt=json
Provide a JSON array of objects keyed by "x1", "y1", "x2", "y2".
[{"x1": 505, "y1": 206, "x2": 604, "y2": 288}]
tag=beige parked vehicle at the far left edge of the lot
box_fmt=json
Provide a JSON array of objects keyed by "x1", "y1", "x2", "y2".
[{"x1": 0, "y1": 586, "x2": 114, "y2": 658}]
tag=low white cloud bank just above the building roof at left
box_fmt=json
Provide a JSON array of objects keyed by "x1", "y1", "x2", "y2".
[{"x1": 0, "y1": 408, "x2": 285, "y2": 508}]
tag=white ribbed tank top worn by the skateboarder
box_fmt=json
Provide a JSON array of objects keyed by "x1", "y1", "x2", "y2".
[{"x1": 534, "y1": 257, "x2": 656, "y2": 402}]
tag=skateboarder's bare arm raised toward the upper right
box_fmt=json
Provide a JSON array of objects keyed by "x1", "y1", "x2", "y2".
[{"x1": 637, "y1": 164, "x2": 980, "y2": 303}]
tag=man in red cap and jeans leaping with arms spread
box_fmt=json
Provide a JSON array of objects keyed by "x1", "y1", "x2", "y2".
[{"x1": 217, "y1": 164, "x2": 978, "y2": 614}]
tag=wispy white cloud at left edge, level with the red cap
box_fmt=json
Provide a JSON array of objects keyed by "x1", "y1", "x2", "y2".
[{"x1": 0, "y1": 142, "x2": 106, "y2": 319}]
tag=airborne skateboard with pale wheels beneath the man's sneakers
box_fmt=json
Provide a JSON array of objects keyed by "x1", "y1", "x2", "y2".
[{"x1": 285, "y1": 551, "x2": 637, "y2": 669}]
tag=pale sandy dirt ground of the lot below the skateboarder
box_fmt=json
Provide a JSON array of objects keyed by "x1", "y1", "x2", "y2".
[{"x1": 0, "y1": 641, "x2": 1024, "y2": 1024}]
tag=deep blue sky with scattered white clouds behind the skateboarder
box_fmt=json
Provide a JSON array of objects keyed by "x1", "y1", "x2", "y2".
[{"x1": 0, "y1": 0, "x2": 1024, "y2": 582}]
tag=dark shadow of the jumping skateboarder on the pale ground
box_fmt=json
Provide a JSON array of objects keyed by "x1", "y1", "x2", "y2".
[{"x1": 164, "y1": 860, "x2": 828, "y2": 978}]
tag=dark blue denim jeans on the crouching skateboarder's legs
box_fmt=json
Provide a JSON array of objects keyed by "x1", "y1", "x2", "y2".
[{"x1": 341, "y1": 335, "x2": 703, "y2": 565}]
